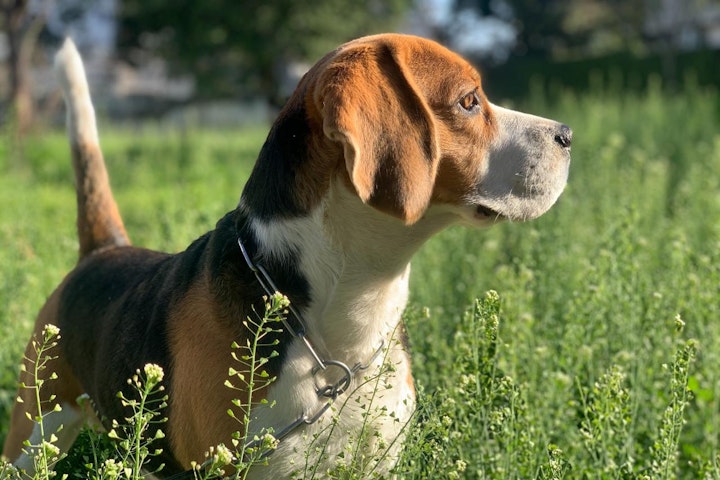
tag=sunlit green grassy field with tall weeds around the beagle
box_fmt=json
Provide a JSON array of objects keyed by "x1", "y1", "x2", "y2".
[{"x1": 0, "y1": 78, "x2": 720, "y2": 479}]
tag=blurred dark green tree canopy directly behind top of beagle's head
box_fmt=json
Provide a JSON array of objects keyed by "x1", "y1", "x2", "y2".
[{"x1": 119, "y1": 0, "x2": 411, "y2": 105}]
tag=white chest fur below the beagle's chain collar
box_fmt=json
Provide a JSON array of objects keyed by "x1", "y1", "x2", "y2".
[{"x1": 249, "y1": 334, "x2": 415, "y2": 479}]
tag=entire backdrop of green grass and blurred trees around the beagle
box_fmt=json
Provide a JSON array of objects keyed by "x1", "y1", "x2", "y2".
[{"x1": 0, "y1": 0, "x2": 720, "y2": 479}]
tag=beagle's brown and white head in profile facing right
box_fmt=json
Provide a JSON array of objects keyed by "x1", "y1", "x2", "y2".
[{"x1": 245, "y1": 34, "x2": 572, "y2": 225}]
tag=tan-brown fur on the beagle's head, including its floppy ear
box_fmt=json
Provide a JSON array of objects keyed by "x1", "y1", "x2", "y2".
[{"x1": 286, "y1": 35, "x2": 512, "y2": 224}]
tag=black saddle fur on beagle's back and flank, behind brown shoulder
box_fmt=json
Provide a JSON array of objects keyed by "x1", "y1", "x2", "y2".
[{"x1": 59, "y1": 247, "x2": 187, "y2": 468}]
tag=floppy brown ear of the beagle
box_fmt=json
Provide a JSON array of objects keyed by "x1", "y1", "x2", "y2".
[{"x1": 315, "y1": 44, "x2": 438, "y2": 224}]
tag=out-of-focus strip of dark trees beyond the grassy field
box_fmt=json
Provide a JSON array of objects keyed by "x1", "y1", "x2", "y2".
[{"x1": 0, "y1": 0, "x2": 720, "y2": 133}]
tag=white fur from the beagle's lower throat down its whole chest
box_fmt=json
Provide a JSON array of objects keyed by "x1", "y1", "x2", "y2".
[{"x1": 242, "y1": 211, "x2": 424, "y2": 479}]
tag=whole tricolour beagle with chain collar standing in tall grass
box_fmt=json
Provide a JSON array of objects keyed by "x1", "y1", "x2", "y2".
[{"x1": 3, "y1": 34, "x2": 572, "y2": 479}]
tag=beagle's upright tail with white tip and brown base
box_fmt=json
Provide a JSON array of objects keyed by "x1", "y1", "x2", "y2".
[{"x1": 55, "y1": 39, "x2": 130, "y2": 259}]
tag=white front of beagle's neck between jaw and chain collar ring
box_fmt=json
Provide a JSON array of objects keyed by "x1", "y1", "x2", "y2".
[{"x1": 240, "y1": 180, "x2": 450, "y2": 362}]
